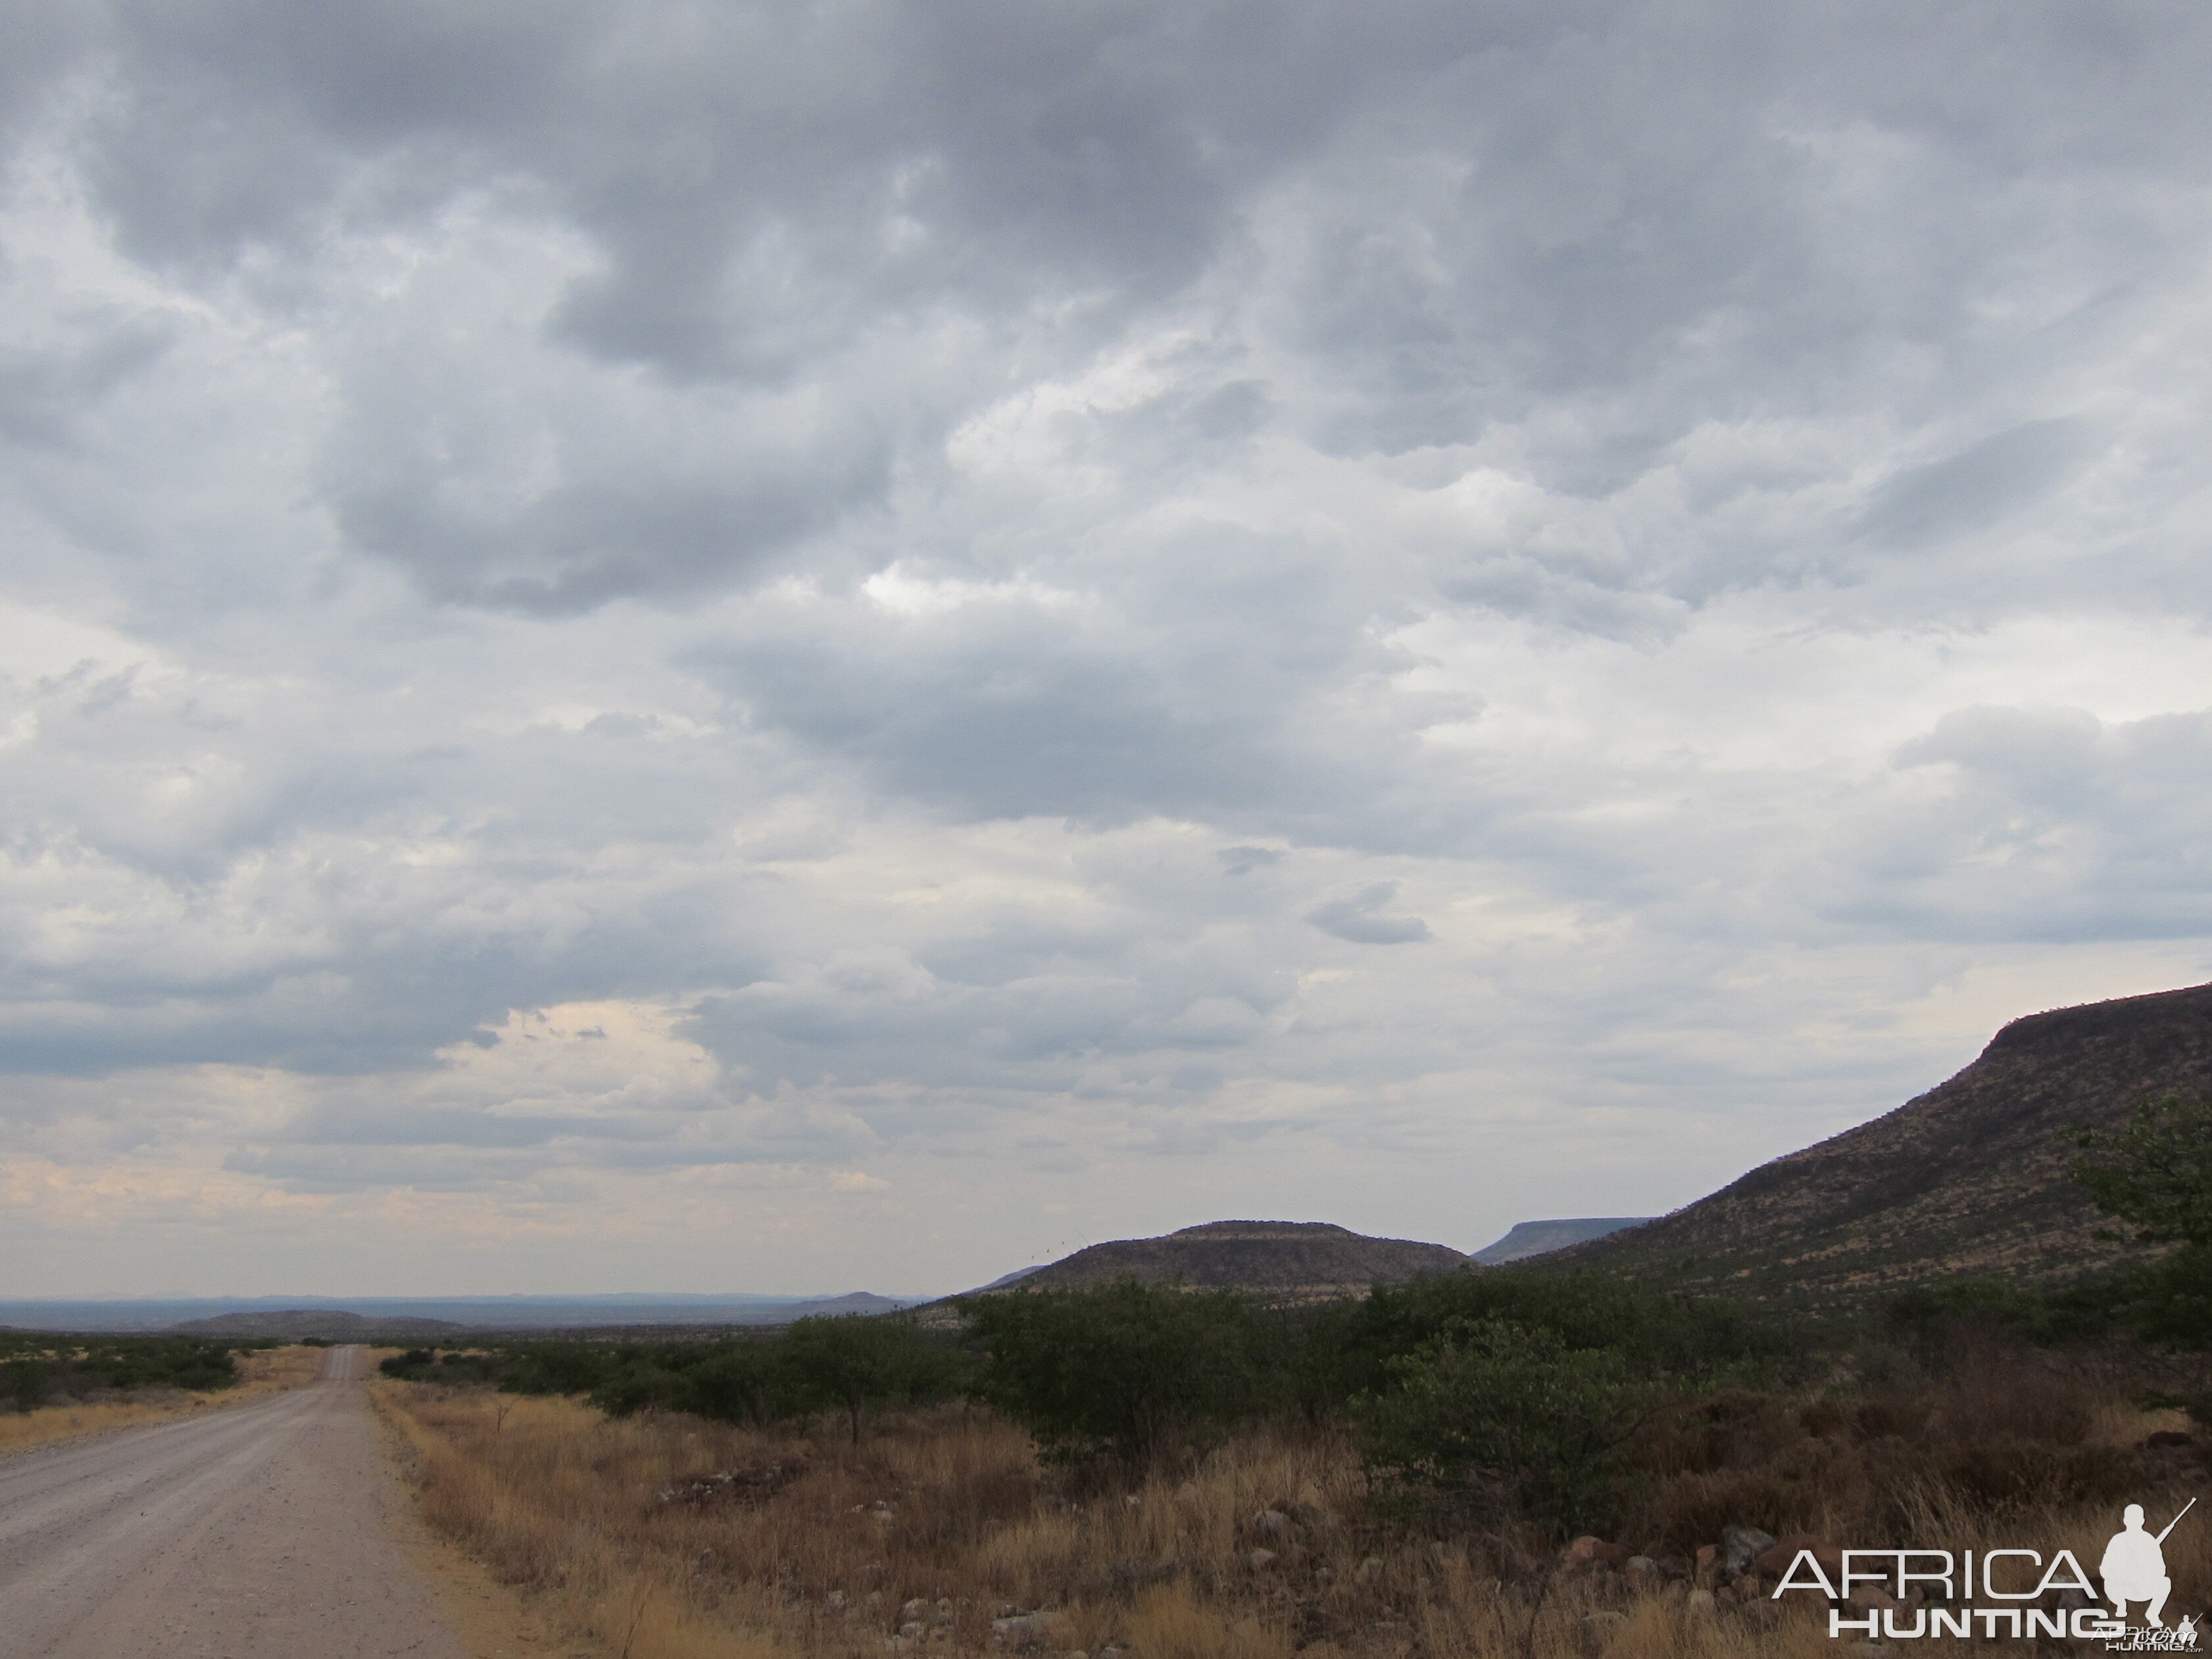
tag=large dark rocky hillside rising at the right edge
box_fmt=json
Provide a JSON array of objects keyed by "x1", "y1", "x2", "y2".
[{"x1": 1553, "y1": 984, "x2": 2212, "y2": 1305}]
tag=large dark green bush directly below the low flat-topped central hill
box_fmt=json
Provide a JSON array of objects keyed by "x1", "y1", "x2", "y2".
[{"x1": 958, "y1": 1279, "x2": 1287, "y2": 1462}]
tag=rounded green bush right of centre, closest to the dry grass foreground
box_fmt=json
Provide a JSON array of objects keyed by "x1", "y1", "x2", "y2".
[{"x1": 1352, "y1": 1318, "x2": 1663, "y2": 1537}]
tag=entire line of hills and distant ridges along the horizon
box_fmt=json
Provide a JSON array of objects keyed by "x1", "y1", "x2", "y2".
[{"x1": 30, "y1": 984, "x2": 2176, "y2": 1341}]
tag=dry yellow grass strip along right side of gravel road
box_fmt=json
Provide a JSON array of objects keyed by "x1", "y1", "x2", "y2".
[{"x1": 374, "y1": 1383, "x2": 2212, "y2": 1659}]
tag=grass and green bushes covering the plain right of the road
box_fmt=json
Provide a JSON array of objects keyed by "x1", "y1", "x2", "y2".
[{"x1": 362, "y1": 1106, "x2": 2212, "y2": 1659}]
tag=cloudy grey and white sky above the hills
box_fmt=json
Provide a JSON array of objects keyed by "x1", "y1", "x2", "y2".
[{"x1": 0, "y1": 0, "x2": 2212, "y2": 1297}]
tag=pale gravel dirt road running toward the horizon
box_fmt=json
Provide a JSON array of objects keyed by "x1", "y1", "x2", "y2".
[{"x1": 0, "y1": 1347, "x2": 464, "y2": 1659}]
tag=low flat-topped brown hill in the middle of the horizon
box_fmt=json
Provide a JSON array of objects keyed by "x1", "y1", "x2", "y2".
[{"x1": 985, "y1": 1221, "x2": 1467, "y2": 1303}]
